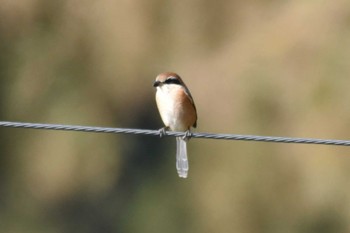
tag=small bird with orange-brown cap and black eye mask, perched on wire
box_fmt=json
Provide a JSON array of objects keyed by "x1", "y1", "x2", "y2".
[{"x1": 153, "y1": 72, "x2": 197, "y2": 178}]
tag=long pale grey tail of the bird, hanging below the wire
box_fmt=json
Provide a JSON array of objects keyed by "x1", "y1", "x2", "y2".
[{"x1": 176, "y1": 137, "x2": 188, "y2": 178}]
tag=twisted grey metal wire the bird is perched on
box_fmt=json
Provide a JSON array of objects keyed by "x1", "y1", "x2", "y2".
[{"x1": 0, "y1": 121, "x2": 350, "y2": 146}]
